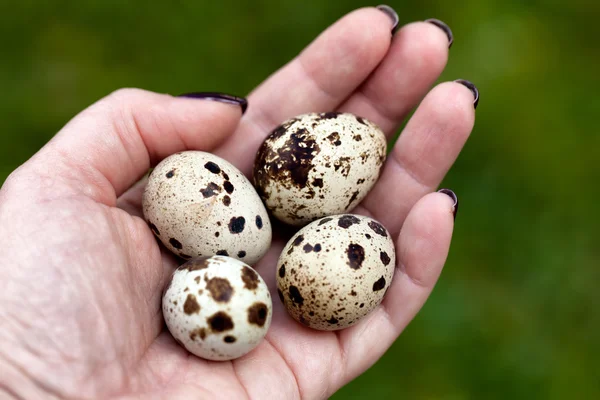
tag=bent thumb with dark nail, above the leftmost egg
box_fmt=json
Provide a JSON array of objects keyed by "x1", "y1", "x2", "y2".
[{"x1": 32, "y1": 89, "x2": 243, "y2": 206}]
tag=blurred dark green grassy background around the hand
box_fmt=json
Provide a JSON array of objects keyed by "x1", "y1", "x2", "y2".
[{"x1": 0, "y1": 0, "x2": 600, "y2": 400}]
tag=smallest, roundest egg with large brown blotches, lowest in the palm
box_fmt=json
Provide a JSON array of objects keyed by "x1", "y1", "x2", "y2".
[{"x1": 162, "y1": 256, "x2": 273, "y2": 361}]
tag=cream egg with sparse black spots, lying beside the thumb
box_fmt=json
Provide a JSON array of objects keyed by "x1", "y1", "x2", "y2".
[{"x1": 143, "y1": 151, "x2": 272, "y2": 265}]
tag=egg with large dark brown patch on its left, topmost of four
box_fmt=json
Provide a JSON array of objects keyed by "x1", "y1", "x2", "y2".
[{"x1": 253, "y1": 112, "x2": 387, "y2": 226}]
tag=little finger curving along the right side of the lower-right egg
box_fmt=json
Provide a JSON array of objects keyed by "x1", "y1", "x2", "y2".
[{"x1": 339, "y1": 193, "x2": 455, "y2": 385}]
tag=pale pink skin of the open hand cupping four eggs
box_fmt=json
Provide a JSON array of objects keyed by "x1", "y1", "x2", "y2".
[{"x1": 0, "y1": 8, "x2": 474, "y2": 399}]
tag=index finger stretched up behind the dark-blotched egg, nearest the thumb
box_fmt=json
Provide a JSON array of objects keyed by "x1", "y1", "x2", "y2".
[{"x1": 217, "y1": 8, "x2": 393, "y2": 174}]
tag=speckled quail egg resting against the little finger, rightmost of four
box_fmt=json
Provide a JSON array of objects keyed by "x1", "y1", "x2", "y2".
[{"x1": 276, "y1": 214, "x2": 396, "y2": 330}]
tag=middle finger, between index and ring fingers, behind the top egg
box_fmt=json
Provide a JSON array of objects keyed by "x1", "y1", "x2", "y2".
[{"x1": 340, "y1": 22, "x2": 448, "y2": 135}]
